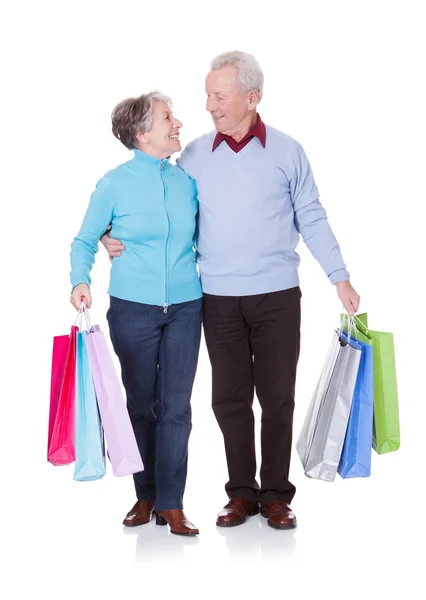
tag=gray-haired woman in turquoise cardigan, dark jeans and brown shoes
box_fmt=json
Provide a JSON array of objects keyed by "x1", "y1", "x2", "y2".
[{"x1": 71, "y1": 92, "x2": 202, "y2": 535}]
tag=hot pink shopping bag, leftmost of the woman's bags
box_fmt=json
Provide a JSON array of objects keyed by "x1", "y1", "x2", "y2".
[{"x1": 47, "y1": 326, "x2": 77, "y2": 465}]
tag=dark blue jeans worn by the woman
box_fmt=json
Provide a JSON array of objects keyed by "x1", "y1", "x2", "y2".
[{"x1": 107, "y1": 296, "x2": 202, "y2": 510}]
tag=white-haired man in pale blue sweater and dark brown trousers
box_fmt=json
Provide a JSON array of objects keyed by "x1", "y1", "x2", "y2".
[{"x1": 102, "y1": 52, "x2": 359, "y2": 529}]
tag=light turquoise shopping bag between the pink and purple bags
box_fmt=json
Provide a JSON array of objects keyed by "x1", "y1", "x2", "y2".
[{"x1": 74, "y1": 331, "x2": 105, "y2": 481}]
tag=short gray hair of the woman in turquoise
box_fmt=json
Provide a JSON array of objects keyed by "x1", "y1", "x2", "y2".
[{"x1": 111, "y1": 91, "x2": 172, "y2": 150}]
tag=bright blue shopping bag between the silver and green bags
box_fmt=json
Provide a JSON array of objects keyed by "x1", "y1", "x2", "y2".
[{"x1": 337, "y1": 332, "x2": 374, "y2": 479}]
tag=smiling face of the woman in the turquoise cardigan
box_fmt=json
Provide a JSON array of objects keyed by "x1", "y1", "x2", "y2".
[{"x1": 141, "y1": 100, "x2": 182, "y2": 158}]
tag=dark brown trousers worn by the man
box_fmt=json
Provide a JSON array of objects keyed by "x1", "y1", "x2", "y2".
[{"x1": 204, "y1": 287, "x2": 301, "y2": 504}]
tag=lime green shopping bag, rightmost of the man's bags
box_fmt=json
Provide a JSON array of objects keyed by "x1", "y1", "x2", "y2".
[{"x1": 343, "y1": 313, "x2": 400, "y2": 454}]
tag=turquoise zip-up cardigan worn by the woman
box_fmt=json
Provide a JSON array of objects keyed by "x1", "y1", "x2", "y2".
[{"x1": 71, "y1": 150, "x2": 202, "y2": 310}]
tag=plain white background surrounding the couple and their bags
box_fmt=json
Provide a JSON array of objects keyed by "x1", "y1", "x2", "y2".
[{"x1": 0, "y1": 0, "x2": 426, "y2": 600}]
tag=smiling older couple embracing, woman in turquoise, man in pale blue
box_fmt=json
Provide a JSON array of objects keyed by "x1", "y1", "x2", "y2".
[{"x1": 71, "y1": 52, "x2": 359, "y2": 535}]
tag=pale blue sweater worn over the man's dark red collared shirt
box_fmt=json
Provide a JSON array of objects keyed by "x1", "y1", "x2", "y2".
[{"x1": 177, "y1": 126, "x2": 349, "y2": 296}]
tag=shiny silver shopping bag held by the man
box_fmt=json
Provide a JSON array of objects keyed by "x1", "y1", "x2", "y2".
[{"x1": 296, "y1": 330, "x2": 361, "y2": 481}]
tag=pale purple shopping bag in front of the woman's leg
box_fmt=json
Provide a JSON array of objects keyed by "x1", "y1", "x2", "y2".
[{"x1": 85, "y1": 325, "x2": 144, "y2": 477}]
